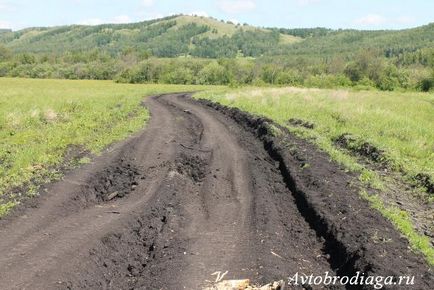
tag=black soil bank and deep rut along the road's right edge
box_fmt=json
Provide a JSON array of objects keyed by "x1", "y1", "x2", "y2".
[{"x1": 201, "y1": 100, "x2": 433, "y2": 289}]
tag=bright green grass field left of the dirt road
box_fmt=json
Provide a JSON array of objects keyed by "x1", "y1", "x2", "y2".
[{"x1": 0, "y1": 78, "x2": 211, "y2": 216}]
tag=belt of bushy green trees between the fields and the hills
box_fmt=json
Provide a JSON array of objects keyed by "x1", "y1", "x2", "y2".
[{"x1": 0, "y1": 46, "x2": 434, "y2": 91}]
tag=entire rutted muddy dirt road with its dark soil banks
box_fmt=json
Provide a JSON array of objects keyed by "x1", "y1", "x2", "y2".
[{"x1": 0, "y1": 94, "x2": 433, "y2": 289}]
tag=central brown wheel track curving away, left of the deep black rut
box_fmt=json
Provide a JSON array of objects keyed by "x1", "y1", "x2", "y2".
[{"x1": 61, "y1": 96, "x2": 333, "y2": 289}]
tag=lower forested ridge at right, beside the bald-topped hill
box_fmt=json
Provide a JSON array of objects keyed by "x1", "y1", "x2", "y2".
[{"x1": 275, "y1": 23, "x2": 434, "y2": 64}]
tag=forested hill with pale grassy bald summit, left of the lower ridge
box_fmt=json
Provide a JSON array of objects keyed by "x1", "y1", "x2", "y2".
[{"x1": 0, "y1": 15, "x2": 300, "y2": 58}]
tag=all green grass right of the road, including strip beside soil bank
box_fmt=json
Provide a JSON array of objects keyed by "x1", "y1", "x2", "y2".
[{"x1": 196, "y1": 88, "x2": 434, "y2": 265}]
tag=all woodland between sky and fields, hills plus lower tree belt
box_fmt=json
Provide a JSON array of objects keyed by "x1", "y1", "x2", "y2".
[{"x1": 0, "y1": 15, "x2": 434, "y2": 91}]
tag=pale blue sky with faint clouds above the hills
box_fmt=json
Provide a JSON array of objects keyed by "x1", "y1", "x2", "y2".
[{"x1": 0, "y1": 0, "x2": 434, "y2": 30}]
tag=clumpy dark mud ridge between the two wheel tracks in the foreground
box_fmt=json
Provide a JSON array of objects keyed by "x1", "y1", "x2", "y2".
[{"x1": 75, "y1": 190, "x2": 185, "y2": 289}]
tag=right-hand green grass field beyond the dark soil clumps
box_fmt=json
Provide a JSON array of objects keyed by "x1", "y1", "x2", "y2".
[{"x1": 198, "y1": 88, "x2": 434, "y2": 188}]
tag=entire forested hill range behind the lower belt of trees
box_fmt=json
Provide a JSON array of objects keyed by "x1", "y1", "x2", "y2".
[{"x1": 0, "y1": 15, "x2": 434, "y2": 63}]
